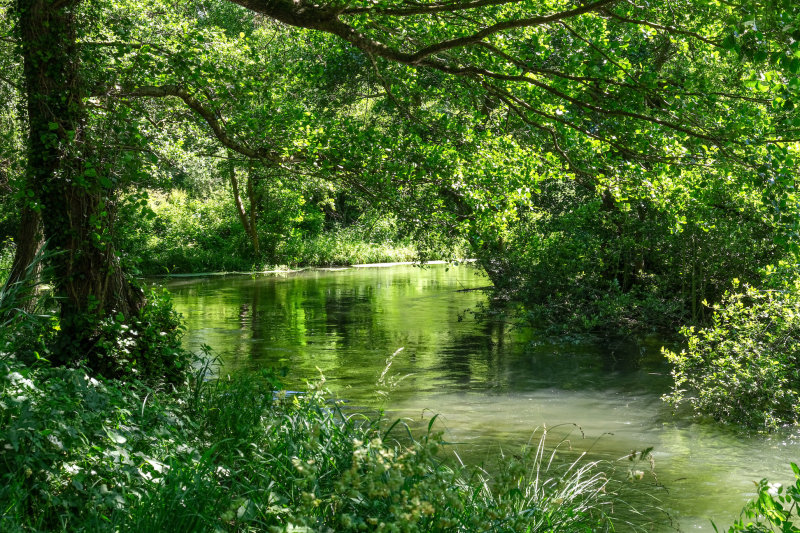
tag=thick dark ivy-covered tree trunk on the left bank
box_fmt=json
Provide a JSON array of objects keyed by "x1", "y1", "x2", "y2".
[{"x1": 17, "y1": 0, "x2": 143, "y2": 363}]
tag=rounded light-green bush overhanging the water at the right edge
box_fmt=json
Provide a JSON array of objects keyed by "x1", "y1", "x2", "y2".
[{"x1": 664, "y1": 276, "x2": 800, "y2": 430}]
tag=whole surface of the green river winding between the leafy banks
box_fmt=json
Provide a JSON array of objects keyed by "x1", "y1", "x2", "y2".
[{"x1": 167, "y1": 265, "x2": 800, "y2": 531}]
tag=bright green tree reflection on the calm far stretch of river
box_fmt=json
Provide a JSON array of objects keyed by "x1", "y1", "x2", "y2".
[{"x1": 171, "y1": 268, "x2": 502, "y2": 394}]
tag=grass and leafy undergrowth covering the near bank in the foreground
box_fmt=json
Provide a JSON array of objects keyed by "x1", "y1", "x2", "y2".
[{"x1": 0, "y1": 352, "x2": 664, "y2": 531}]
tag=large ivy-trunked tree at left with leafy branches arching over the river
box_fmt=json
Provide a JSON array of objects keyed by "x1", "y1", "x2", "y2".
[{"x1": 4, "y1": 0, "x2": 797, "y2": 361}]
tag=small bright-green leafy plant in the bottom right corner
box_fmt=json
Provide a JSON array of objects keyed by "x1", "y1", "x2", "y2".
[{"x1": 714, "y1": 463, "x2": 800, "y2": 533}]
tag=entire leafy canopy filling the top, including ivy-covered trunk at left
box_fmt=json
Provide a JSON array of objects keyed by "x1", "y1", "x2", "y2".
[{"x1": 0, "y1": 0, "x2": 800, "y2": 359}]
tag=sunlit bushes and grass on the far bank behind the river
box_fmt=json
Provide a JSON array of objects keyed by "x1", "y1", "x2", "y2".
[{"x1": 118, "y1": 189, "x2": 424, "y2": 274}]
